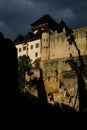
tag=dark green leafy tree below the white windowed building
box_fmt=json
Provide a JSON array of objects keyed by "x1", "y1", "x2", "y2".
[{"x1": 18, "y1": 55, "x2": 32, "y2": 89}]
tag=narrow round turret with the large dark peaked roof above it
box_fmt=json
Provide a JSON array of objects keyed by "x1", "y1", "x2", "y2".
[{"x1": 31, "y1": 14, "x2": 58, "y2": 60}]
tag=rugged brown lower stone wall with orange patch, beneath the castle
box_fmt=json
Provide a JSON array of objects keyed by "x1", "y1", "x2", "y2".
[{"x1": 41, "y1": 59, "x2": 79, "y2": 109}]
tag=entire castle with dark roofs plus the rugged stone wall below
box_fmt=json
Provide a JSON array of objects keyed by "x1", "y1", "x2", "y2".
[{"x1": 14, "y1": 14, "x2": 87, "y2": 107}]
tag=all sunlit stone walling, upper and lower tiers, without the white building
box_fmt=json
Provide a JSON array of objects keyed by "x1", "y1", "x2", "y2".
[{"x1": 23, "y1": 28, "x2": 87, "y2": 110}]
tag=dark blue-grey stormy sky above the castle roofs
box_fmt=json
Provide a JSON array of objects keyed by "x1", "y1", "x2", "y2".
[{"x1": 0, "y1": 0, "x2": 87, "y2": 39}]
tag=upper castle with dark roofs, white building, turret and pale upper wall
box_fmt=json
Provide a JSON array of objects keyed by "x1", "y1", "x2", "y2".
[{"x1": 14, "y1": 15, "x2": 87, "y2": 63}]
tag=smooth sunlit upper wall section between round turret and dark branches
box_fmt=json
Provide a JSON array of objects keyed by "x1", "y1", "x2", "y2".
[{"x1": 50, "y1": 33, "x2": 69, "y2": 59}]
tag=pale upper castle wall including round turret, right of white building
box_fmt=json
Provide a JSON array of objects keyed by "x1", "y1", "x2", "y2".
[{"x1": 41, "y1": 28, "x2": 87, "y2": 60}]
